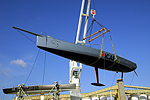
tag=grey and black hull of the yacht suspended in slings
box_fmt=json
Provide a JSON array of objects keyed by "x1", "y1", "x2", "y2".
[{"x1": 37, "y1": 36, "x2": 137, "y2": 72}]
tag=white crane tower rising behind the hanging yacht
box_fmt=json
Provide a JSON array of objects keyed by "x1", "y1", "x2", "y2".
[{"x1": 69, "y1": 0, "x2": 91, "y2": 100}]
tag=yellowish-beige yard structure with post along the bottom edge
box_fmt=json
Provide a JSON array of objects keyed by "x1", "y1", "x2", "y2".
[{"x1": 13, "y1": 80, "x2": 150, "y2": 100}]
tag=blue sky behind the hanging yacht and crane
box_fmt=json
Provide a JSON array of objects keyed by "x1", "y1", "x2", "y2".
[{"x1": 0, "y1": 0, "x2": 150, "y2": 100}]
